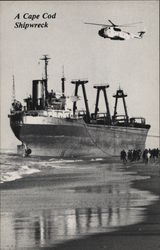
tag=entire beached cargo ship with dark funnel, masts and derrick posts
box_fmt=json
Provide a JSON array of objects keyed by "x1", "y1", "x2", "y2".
[{"x1": 9, "y1": 55, "x2": 150, "y2": 157}]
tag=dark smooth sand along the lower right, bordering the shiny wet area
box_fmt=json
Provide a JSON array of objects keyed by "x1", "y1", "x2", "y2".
[{"x1": 39, "y1": 162, "x2": 160, "y2": 250}]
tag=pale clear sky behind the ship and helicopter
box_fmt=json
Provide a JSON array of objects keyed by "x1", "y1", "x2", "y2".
[{"x1": 0, "y1": 1, "x2": 159, "y2": 148}]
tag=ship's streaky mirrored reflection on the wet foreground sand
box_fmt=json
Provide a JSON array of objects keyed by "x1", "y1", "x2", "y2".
[{"x1": 12, "y1": 207, "x2": 126, "y2": 249}]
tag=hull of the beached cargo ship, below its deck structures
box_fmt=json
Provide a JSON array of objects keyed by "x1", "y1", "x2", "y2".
[{"x1": 11, "y1": 116, "x2": 148, "y2": 157}]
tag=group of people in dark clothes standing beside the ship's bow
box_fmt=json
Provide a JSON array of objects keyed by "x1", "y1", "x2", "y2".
[{"x1": 120, "y1": 148, "x2": 160, "y2": 163}]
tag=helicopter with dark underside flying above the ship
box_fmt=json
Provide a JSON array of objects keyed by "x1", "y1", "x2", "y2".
[{"x1": 84, "y1": 20, "x2": 145, "y2": 41}]
